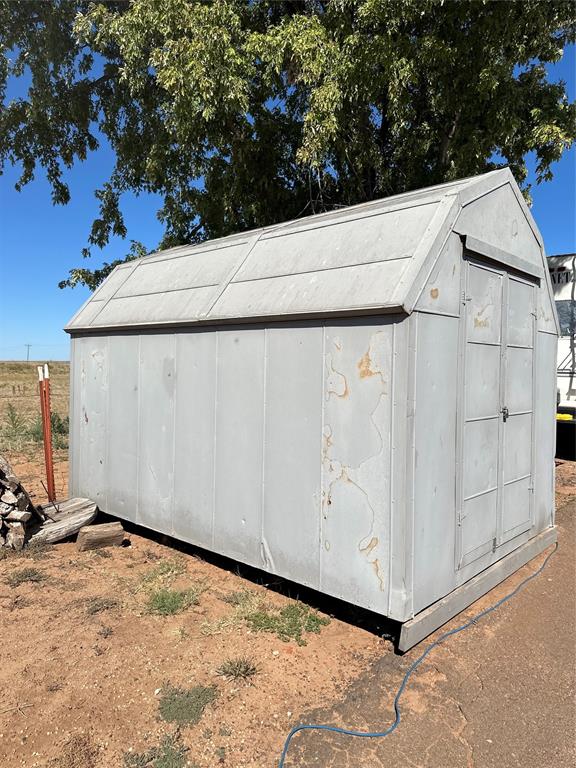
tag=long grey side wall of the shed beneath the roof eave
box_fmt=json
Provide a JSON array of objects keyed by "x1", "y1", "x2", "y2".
[{"x1": 71, "y1": 317, "x2": 408, "y2": 618}]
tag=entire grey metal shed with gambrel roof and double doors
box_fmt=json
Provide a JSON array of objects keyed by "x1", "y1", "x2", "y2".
[{"x1": 67, "y1": 170, "x2": 558, "y2": 650}]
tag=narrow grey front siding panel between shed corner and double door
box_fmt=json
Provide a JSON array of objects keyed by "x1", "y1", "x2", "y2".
[{"x1": 414, "y1": 314, "x2": 459, "y2": 613}]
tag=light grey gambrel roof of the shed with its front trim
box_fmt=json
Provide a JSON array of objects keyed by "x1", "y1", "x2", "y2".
[{"x1": 66, "y1": 169, "x2": 541, "y2": 332}]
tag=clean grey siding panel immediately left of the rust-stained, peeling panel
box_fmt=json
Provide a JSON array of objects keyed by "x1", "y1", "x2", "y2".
[{"x1": 261, "y1": 327, "x2": 322, "y2": 588}]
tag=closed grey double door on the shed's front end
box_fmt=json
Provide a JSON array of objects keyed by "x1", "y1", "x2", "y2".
[{"x1": 458, "y1": 261, "x2": 535, "y2": 567}]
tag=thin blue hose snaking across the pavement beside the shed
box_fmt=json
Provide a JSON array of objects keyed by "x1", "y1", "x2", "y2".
[{"x1": 278, "y1": 542, "x2": 558, "y2": 768}]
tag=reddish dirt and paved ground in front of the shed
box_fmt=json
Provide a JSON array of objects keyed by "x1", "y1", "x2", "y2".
[{"x1": 0, "y1": 362, "x2": 576, "y2": 768}]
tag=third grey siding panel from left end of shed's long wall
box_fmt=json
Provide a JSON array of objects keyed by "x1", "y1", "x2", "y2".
[{"x1": 136, "y1": 334, "x2": 175, "y2": 534}]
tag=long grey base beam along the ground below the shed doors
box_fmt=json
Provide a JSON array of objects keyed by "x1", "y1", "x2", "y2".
[{"x1": 398, "y1": 527, "x2": 558, "y2": 653}]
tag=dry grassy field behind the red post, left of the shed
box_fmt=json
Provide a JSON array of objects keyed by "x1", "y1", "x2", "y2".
[{"x1": 0, "y1": 362, "x2": 70, "y2": 501}]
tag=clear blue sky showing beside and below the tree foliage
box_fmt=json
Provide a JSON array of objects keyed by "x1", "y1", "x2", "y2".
[{"x1": 0, "y1": 46, "x2": 576, "y2": 360}]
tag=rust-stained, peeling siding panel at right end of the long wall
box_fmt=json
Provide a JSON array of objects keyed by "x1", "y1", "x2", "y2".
[{"x1": 320, "y1": 321, "x2": 393, "y2": 612}]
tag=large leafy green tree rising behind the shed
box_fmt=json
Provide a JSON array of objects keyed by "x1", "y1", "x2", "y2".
[{"x1": 0, "y1": 0, "x2": 576, "y2": 287}]
